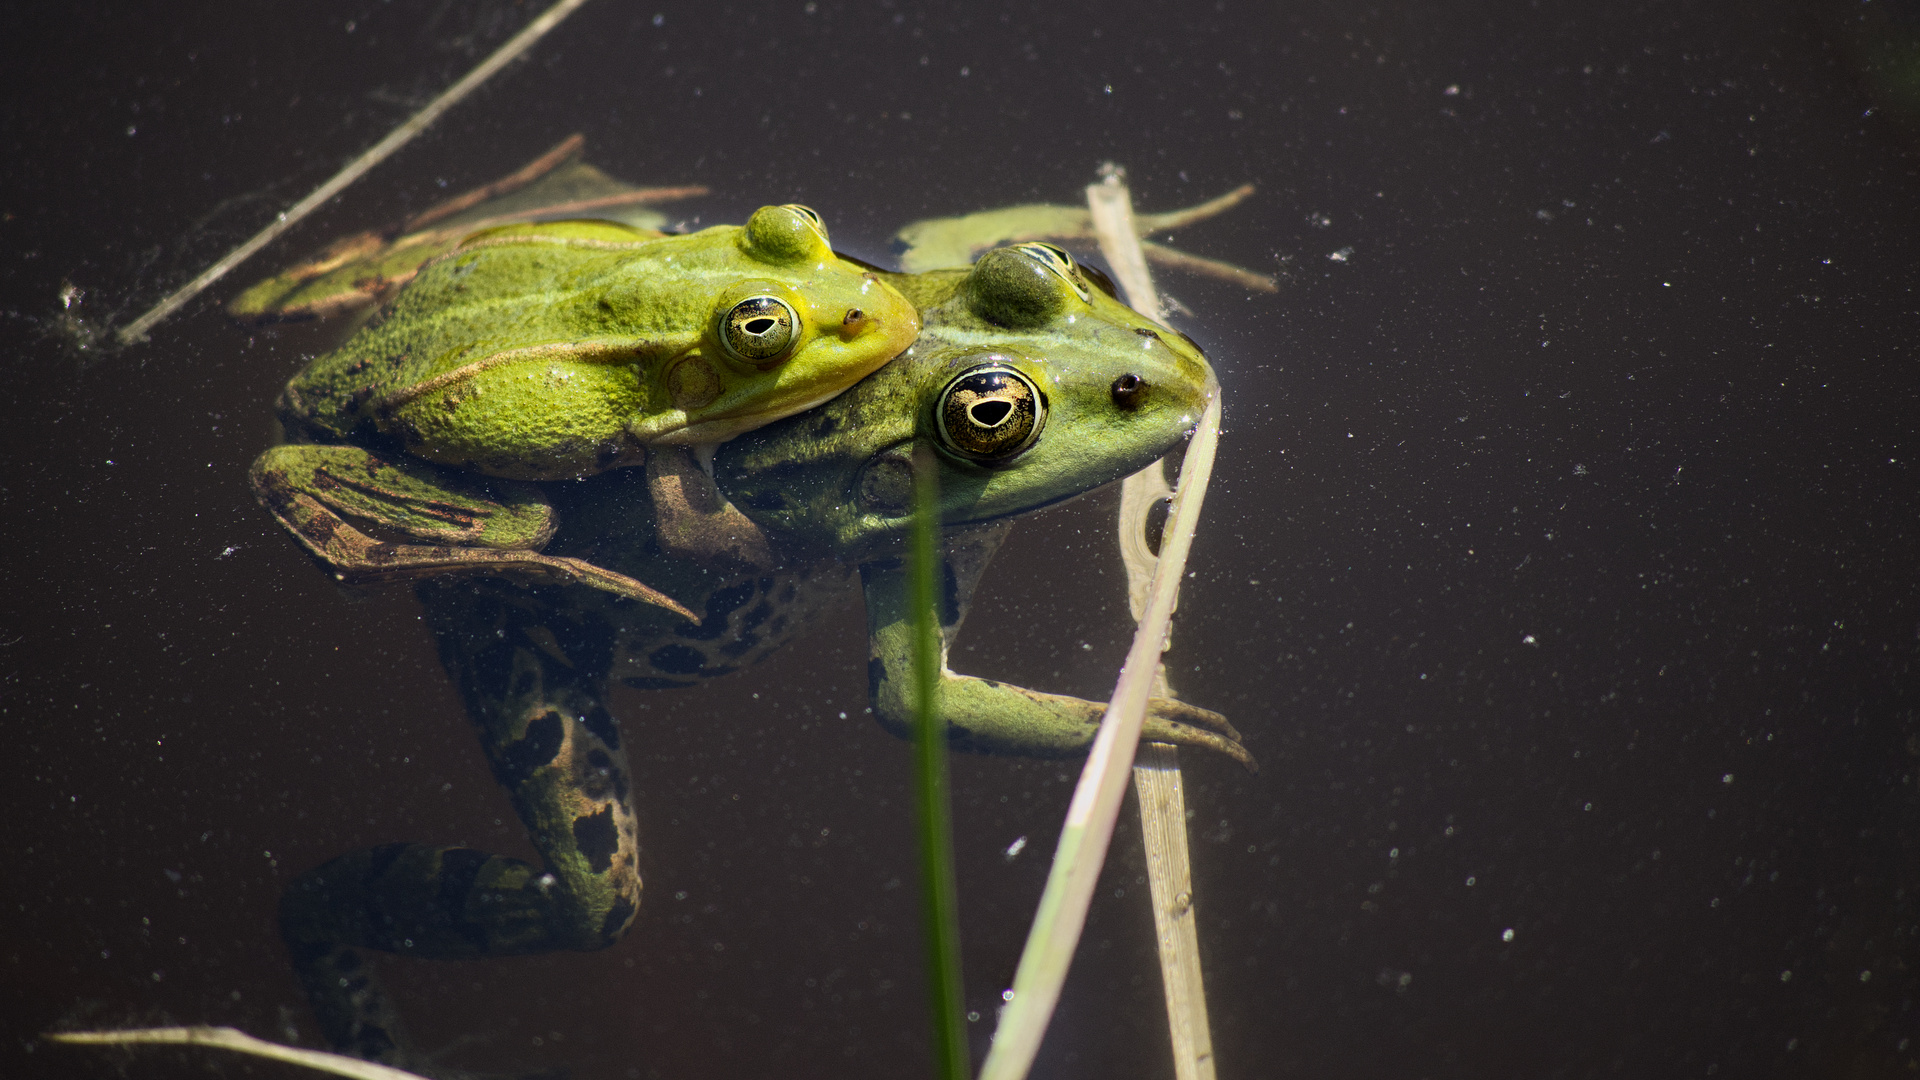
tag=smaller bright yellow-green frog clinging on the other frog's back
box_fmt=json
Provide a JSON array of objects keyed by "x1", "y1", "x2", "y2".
[{"x1": 252, "y1": 206, "x2": 920, "y2": 617}]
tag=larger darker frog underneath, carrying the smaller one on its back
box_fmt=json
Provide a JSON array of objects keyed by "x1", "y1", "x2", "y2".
[{"x1": 280, "y1": 244, "x2": 1252, "y2": 1061}]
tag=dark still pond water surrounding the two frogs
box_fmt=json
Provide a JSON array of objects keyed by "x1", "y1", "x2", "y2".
[{"x1": 0, "y1": 0, "x2": 1920, "y2": 1080}]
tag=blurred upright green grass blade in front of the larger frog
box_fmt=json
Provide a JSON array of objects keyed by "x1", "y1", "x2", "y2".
[{"x1": 910, "y1": 446, "x2": 972, "y2": 1080}]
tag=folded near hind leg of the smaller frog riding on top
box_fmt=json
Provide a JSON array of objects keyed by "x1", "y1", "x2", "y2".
[{"x1": 250, "y1": 444, "x2": 699, "y2": 623}]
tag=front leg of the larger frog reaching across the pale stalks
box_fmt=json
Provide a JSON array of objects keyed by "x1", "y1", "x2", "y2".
[{"x1": 860, "y1": 525, "x2": 1254, "y2": 769}]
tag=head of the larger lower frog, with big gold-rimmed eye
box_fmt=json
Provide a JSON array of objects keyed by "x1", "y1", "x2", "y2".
[{"x1": 714, "y1": 244, "x2": 1217, "y2": 553}]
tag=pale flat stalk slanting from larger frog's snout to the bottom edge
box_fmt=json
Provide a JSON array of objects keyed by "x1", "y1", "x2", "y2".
[{"x1": 981, "y1": 386, "x2": 1219, "y2": 1080}]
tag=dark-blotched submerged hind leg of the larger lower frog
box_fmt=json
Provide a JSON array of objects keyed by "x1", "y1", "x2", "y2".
[{"x1": 280, "y1": 582, "x2": 641, "y2": 1070}]
